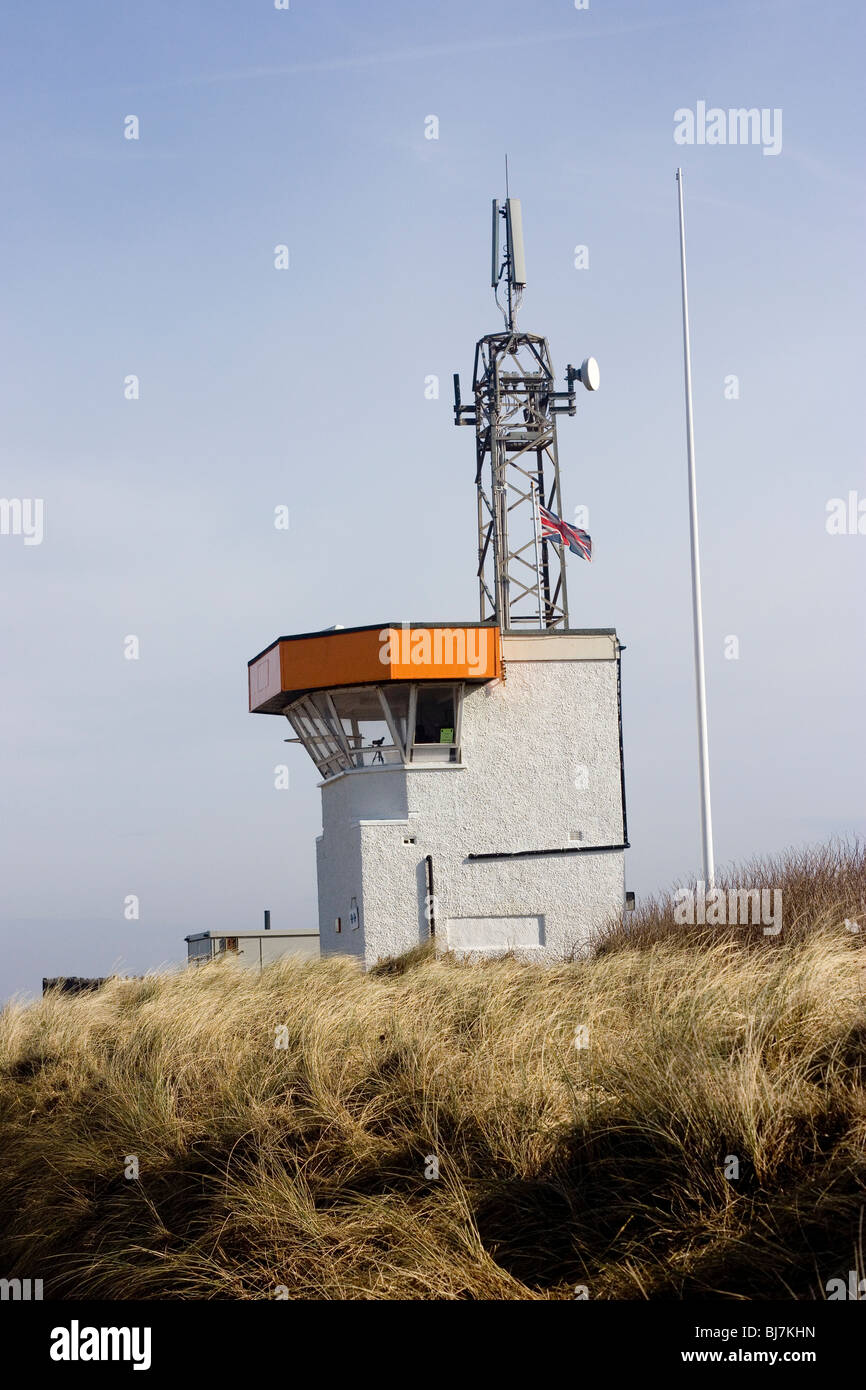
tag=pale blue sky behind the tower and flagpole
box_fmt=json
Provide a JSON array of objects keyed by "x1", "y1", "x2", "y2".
[{"x1": 0, "y1": 0, "x2": 866, "y2": 995}]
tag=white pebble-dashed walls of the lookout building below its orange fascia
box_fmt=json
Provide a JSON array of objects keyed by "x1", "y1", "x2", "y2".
[{"x1": 317, "y1": 637, "x2": 624, "y2": 965}]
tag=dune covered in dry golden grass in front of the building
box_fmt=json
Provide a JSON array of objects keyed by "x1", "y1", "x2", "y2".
[{"x1": 0, "y1": 848, "x2": 866, "y2": 1298}]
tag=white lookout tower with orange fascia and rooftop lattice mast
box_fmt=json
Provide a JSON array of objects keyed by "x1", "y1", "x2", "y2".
[{"x1": 249, "y1": 199, "x2": 628, "y2": 965}]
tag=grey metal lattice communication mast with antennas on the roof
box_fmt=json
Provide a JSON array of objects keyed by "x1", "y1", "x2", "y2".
[{"x1": 455, "y1": 197, "x2": 599, "y2": 632}]
